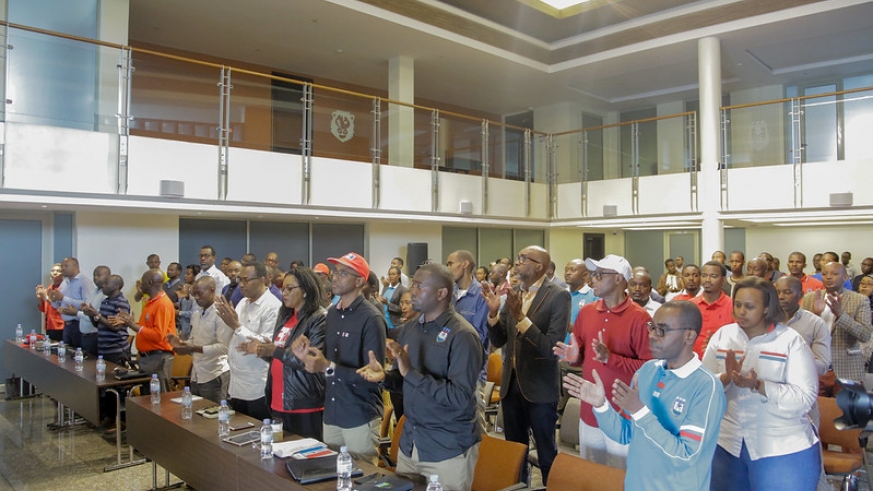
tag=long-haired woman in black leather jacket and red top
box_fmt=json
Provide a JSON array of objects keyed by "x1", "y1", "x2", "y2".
[{"x1": 249, "y1": 266, "x2": 326, "y2": 440}]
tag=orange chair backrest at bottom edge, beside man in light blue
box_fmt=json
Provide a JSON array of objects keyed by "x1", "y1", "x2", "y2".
[{"x1": 546, "y1": 452, "x2": 624, "y2": 491}]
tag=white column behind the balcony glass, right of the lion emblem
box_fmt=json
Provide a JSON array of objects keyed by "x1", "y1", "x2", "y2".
[{"x1": 388, "y1": 56, "x2": 416, "y2": 167}]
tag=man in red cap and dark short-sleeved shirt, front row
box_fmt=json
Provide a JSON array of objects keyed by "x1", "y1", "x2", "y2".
[{"x1": 292, "y1": 252, "x2": 388, "y2": 463}]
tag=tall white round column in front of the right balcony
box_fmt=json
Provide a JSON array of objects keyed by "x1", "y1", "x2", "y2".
[{"x1": 697, "y1": 37, "x2": 724, "y2": 256}]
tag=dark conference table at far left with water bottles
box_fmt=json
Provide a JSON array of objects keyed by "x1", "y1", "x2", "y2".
[{"x1": 3, "y1": 339, "x2": 150, "y2": 471}]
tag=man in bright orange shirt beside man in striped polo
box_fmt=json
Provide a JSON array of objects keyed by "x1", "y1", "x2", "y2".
[{"x1": 116, "y1": 269, "x2": 176, "y2": 390}]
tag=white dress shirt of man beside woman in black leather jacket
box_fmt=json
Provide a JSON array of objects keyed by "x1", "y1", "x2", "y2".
[{"x1": 227, "y1": 289, "x2": 282, "y2": 401}]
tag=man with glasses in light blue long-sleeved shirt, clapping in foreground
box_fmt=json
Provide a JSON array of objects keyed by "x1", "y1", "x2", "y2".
[{"x1": 564, "y1": 301, "x2": 725, "y2": 491}]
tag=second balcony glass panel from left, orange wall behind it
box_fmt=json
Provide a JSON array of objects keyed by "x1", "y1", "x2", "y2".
[{"x1": 130, "y1": 52, "x2": 221, "y2": 145}]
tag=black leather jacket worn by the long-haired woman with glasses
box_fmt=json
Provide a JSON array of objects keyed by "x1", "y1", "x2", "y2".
[{"x1": 265, "y1": 307, "x2": 327, "y2": 411}]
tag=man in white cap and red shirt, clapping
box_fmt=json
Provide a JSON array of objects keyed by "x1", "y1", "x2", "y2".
[{"x1": 555, "y1": 254, "x2": 652, "y2": 468}]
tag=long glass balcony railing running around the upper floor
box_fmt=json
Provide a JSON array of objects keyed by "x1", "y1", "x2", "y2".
[{"x1": 5, "y1": 24, "x2": 873, "y2": 198}]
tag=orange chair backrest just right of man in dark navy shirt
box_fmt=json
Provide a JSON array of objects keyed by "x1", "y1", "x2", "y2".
[{"x1": 473, "y1": 435, "x2": 527, "y2": 491}]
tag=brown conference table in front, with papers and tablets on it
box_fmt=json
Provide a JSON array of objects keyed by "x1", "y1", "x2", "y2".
[{"x1": 127, "y1": 392, "x2": 424, "y2": 491}]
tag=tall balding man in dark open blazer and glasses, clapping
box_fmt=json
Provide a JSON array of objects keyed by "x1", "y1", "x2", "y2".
[{"x1": 482, "y1": 246, "x2": 570, "y2": 484}]
